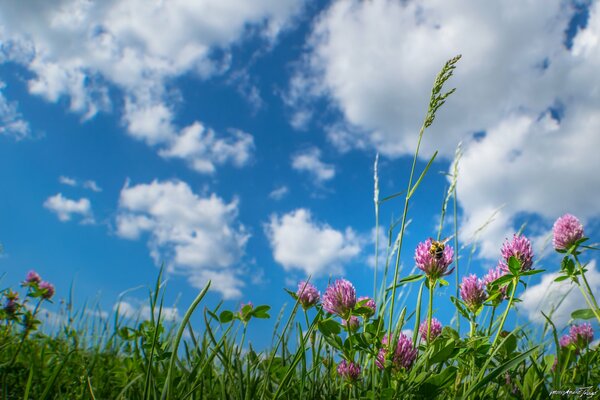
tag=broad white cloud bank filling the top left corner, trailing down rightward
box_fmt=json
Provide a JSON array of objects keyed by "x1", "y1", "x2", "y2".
[{"x1": 0, "y1": 0, "x2": 303, "y2": 172}]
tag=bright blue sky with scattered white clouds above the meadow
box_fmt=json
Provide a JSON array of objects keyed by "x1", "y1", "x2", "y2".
[{"x1": 0, "y1": 0, "x2": 600, "y2": 344}]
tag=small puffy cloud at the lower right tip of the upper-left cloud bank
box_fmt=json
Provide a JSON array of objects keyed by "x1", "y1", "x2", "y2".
[{"x1": 160, "y1": 122, "x2": 254, "y2": 173}]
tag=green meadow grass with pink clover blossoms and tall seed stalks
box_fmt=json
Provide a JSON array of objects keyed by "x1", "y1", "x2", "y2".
[{"x1": 0, "y1": 57, "x2": 600, "y2": 400}]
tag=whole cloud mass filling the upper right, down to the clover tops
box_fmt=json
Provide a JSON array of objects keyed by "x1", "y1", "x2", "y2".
[{"x1": 286, "y1": 0, "x2": 600, "y2": 257}]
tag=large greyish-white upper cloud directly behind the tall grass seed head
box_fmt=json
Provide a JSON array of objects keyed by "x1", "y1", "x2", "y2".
[{"x1": 290, "y1": 0, "x2": 569, "y2": 156}]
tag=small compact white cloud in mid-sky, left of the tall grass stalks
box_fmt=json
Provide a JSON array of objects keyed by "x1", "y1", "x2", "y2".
[{"x1": 265, "y1": 208, "x2": 361, "y2": 277}]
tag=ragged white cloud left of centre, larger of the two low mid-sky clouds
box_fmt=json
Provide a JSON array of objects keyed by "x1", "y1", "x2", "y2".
[{"x1": 116, "y1": 181, "x2": 249, "y2": 298}]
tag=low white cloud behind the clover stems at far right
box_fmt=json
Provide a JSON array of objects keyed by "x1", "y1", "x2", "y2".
[{"x1": 519, "y1": 261, "x2": 600, "y2": 329}]
